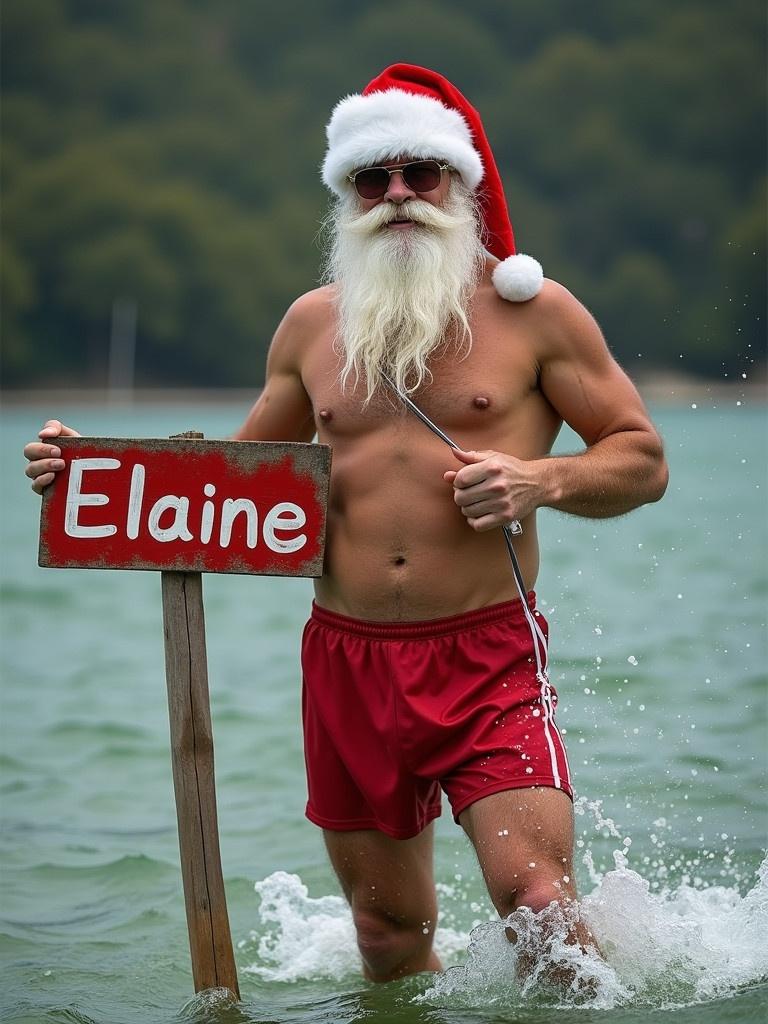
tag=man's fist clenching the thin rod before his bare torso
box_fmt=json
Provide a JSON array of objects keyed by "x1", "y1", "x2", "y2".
[{"x1": 443, "y1": 449, "x2": 542, "y2": 532}]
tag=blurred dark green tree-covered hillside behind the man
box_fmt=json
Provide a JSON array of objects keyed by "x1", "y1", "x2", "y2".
[{"x1": 1, "y1": 0, "x2": 766, "y2": 387}]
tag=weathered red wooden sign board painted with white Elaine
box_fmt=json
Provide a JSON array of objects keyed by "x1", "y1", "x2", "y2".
[{"x1": 39, "y1": 437, "x2": 331, "y2": 577}]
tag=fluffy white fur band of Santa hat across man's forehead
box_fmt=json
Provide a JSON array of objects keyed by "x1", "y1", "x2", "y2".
[{"x1": 323, "y1": 89, "x2": 482, "y2": 196}]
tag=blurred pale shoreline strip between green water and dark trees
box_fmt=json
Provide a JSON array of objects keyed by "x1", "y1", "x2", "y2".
[{"x1": 0, "y1": 372, "x2": 768, "y2": 408}]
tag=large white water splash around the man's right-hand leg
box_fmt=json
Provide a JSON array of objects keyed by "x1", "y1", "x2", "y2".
[{"x1": 418, "y1": 851, "x2": 768, "y2": 1009}]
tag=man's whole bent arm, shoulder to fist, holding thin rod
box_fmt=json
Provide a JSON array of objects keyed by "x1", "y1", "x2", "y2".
[{"x1": 446, "y1": 282, "x2": 668, "y2": 531}]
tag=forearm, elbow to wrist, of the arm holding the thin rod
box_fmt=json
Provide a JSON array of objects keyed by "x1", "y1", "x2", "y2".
[{"x1": 531, "y1": 430, "x2": 668, "y2": 519}]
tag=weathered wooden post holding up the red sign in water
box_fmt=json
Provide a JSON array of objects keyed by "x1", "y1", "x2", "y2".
[{"x1": 161, "y1": 432, "x2": 240, "y2": 999}]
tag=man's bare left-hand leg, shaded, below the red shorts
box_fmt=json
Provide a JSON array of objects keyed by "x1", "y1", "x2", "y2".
[{"x1": 324, "y1": 825, "x2": 440, "y2": 981}]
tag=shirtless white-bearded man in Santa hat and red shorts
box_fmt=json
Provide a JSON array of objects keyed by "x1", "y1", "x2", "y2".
[{"x1": 25, "y1": 65, "x2": 667, "y2": 981}]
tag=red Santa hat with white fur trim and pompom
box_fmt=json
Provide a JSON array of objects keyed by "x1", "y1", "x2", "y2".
[{"x1": 323, "y1": 63, "x2": 544, "y2": 302}]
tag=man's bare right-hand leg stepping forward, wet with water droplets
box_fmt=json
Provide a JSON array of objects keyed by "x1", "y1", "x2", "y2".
[{"x1": 460, "y1": 787, "x2": 597, "y2": 981}]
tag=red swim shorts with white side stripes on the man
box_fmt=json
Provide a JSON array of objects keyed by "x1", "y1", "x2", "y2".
[{"x1": 301, "y1": 593, "x2": 572, "y2": 839}]
